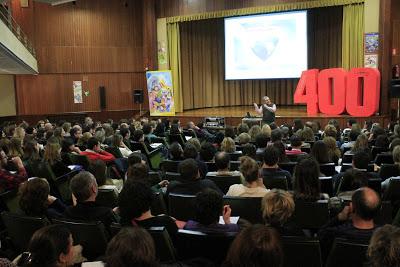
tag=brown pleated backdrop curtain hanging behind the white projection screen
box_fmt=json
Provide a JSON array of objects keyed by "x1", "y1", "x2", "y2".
[{"x1": 179, "y1": 7, "x2": 343, "y2": 110}]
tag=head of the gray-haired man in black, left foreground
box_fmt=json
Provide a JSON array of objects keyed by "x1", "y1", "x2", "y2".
[{"x1": 69, "y1": 171, "x2": 97, "y2": 203}]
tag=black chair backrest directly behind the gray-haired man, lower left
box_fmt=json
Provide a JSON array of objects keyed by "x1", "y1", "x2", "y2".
[{"x1": 53, "y1": 219, "x2": 107, "y2": 260}]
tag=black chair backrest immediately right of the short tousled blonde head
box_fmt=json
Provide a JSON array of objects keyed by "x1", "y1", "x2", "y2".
[{"x1": 292, "y1": 200, "x2": 329, "y2": 229}]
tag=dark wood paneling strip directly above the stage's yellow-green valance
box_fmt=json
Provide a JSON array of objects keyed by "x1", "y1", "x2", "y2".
[{"x1": 156, "y1": 0, "x2": 307, "y2": 18}]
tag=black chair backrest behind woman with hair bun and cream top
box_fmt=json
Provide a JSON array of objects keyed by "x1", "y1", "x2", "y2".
[{"x1": 224, "y1": 196, "x2": 263, "y2": 223}]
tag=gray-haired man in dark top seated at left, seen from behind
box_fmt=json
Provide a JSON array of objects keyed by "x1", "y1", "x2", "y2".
[{"x1": 64, "y1": 171, "x2": 118, "y2": 228}]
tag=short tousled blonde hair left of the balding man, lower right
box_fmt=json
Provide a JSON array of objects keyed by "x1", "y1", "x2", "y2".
[{"x1": 261, "y1": 189, "x2": 295, "y2": 226}]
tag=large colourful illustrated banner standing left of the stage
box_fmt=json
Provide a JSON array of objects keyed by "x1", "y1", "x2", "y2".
[{"x1": 146, "y1": 70, "x2": 175, "y2": 116}]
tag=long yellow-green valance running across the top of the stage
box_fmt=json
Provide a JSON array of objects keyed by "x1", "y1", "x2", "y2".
[{"x1": 167, "y1": 0, "x2": 364, "y2": 23}]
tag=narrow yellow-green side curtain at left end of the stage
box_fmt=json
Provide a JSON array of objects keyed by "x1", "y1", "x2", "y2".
[{"x1": 167, "y1": 23, "x2": 183, "y2": 112}]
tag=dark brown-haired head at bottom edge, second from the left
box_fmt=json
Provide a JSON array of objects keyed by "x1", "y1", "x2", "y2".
[{"x1": 105, "y1": 227, "x2": 158, "y2": 267}]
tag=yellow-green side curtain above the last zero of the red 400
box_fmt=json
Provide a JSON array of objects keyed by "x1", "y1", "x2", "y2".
[{"x1": 342, "y1": 4, "x2": 364, "y2": 69}]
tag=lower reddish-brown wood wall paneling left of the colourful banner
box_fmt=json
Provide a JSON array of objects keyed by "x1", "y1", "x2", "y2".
[{"x1": 16, "y1": 72, "x2": 148, "y2": 115}]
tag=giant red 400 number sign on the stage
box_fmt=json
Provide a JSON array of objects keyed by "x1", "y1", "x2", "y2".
[{"x1": 294, "y1": 68, "x2": 381, "y2": 117}]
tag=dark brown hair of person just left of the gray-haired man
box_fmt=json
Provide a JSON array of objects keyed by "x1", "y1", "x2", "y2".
[{"x1": 19, "y1": 178, "x2": 50, "y2": 217}]
